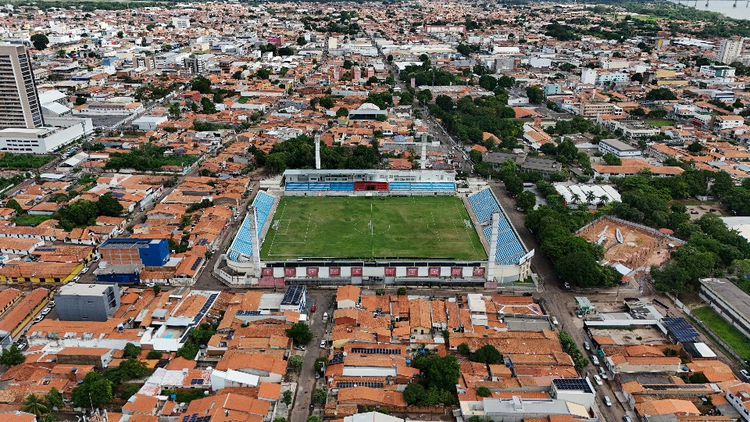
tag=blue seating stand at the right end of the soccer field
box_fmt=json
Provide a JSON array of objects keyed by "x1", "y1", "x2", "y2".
[{"x1": 469, "y1": 188, "x2": 526, "y2": 265}]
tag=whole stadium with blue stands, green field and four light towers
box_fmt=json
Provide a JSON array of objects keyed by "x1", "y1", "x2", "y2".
[{"x1": 215, "y1": 170, "x2": 533, "y2": 287}]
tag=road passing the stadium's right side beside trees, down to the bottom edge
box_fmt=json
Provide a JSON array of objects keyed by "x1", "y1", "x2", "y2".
[{"x1": 490, "y1": 182, "x2": 627, "y2": 422}]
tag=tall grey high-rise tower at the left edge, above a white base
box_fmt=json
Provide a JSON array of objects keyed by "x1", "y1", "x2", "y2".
[{"x1": 0, "y1": 45, "x2": 44, "y2": 129}]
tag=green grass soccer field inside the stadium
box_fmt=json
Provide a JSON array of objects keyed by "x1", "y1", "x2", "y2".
[{"x1": 261, "y1": 196, "x2": 487, "y2": 261}]
